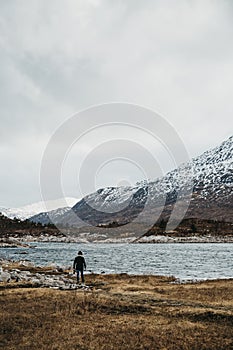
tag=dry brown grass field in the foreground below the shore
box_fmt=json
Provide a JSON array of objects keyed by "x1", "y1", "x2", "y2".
[{"x1": 0, "y1": 275, "x2": 233, "y2": 350}]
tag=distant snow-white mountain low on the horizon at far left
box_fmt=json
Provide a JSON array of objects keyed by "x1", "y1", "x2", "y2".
[{"x1": 0, "y1": 197, "x2": 77, "y2": 220}]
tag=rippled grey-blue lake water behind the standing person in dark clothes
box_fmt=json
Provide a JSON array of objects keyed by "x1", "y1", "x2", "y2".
[{"x1": 0, "y1": 242, "x2": 233, "y2": 280}]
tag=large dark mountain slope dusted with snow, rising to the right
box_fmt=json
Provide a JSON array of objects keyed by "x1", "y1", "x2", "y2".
[{"x1": 31, "y1": 136, "x2": 233, "y2": 226}]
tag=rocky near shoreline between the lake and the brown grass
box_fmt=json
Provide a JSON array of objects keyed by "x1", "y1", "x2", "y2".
[{"x1": 0, "y1": 259, "x2": 233, "y2": 290}]
